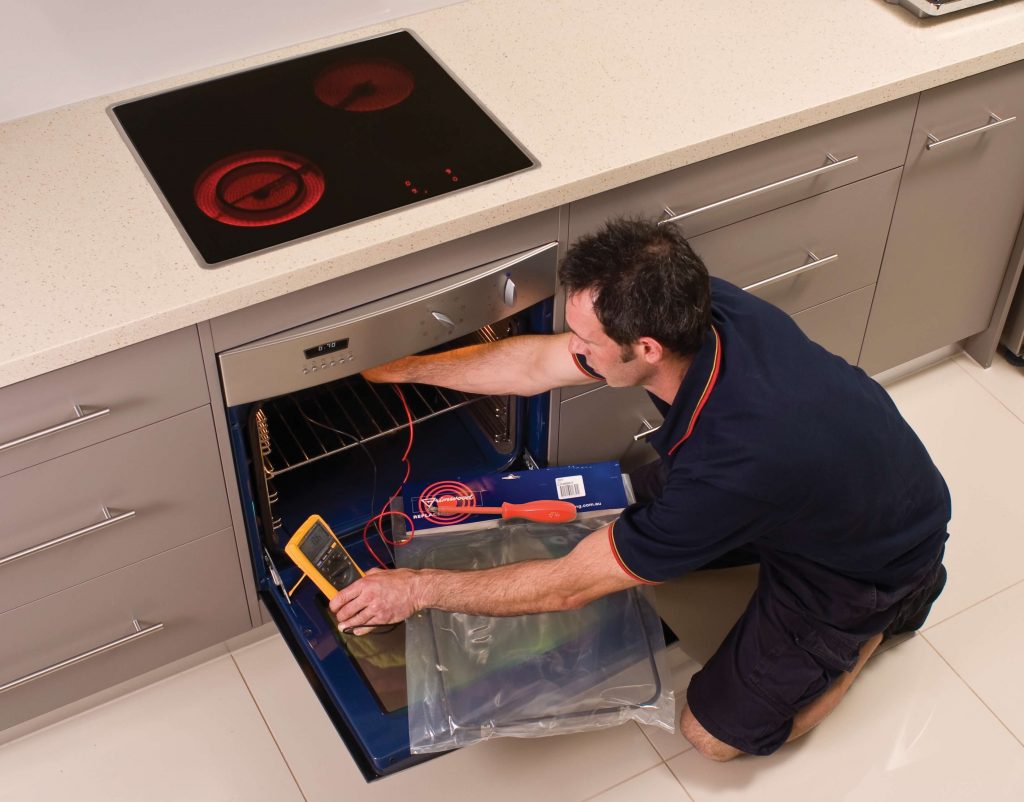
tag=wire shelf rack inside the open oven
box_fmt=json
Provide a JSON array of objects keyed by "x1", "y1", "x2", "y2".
[{"x1": 256, "y1": 376, "x2": 513, "y2": 479}]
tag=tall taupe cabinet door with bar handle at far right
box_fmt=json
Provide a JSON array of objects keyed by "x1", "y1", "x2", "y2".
[{"x1": 861, "y1": 62, "x2": 1024, "y2": 373}]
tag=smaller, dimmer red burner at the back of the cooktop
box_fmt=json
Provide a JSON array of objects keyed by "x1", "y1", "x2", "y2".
[{"x1": 313, "y1": 58, "x2": 416, "y2": 112}]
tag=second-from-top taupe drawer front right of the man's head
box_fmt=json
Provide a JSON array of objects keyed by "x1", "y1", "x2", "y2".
[{"x1": 690, "y1": 169, "x2": 900, "y2": 314}]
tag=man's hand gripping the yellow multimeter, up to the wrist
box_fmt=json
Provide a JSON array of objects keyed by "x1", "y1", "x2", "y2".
[{"x1": 329, "y1": 568, "x2": 419, "y2": 635}]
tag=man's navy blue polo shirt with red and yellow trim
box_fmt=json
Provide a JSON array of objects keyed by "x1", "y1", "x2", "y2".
[{"x1": 609, "y1": 279, "x2": 950, "y2": 588}]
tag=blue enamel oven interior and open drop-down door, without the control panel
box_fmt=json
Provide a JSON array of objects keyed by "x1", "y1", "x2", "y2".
[{"x1": 228, "y1": 299, "x2": 553, "y2": 779}]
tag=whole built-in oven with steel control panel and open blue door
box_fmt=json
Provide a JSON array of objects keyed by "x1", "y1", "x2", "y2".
[{"x1": 218, "y1": 241, "x2": 557, "y2": 779}]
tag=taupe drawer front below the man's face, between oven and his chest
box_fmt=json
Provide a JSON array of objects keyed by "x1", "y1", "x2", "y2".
[{"x1": 556, "y1": 386, "x2": 662, "y2": 471}]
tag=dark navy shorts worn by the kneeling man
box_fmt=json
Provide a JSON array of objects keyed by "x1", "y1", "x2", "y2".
[{"x1": 631, "y1": 464, "x2": 945, "y2": 755}]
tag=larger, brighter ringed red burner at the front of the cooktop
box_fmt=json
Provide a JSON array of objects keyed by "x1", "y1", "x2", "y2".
[{"x1": 194, "y1": 151, "x2": 325, "y2": 227}]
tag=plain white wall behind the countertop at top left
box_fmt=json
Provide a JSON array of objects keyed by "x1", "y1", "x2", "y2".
[{"x1": 0, "y1": 0, "x2": 453, "y2": 122}]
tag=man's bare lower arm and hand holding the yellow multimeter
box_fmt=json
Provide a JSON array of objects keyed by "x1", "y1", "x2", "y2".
[{"x1": 330, "y1": 527, "x2": 639, "y2": 631}]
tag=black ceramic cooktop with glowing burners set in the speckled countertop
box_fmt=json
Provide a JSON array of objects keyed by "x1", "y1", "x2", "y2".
[{"x1": 113, "y1": 31, "x2": 534, "y2": 265}]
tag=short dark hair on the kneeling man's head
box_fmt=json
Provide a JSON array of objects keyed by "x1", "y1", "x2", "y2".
[{"x1": 558, "y1": 218, "x2": 711, "y2": 356}]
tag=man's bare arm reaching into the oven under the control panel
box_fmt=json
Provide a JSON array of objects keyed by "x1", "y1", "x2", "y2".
[{"x1": 362, "y1": 334, "x2": 595, "y2": 395}]
